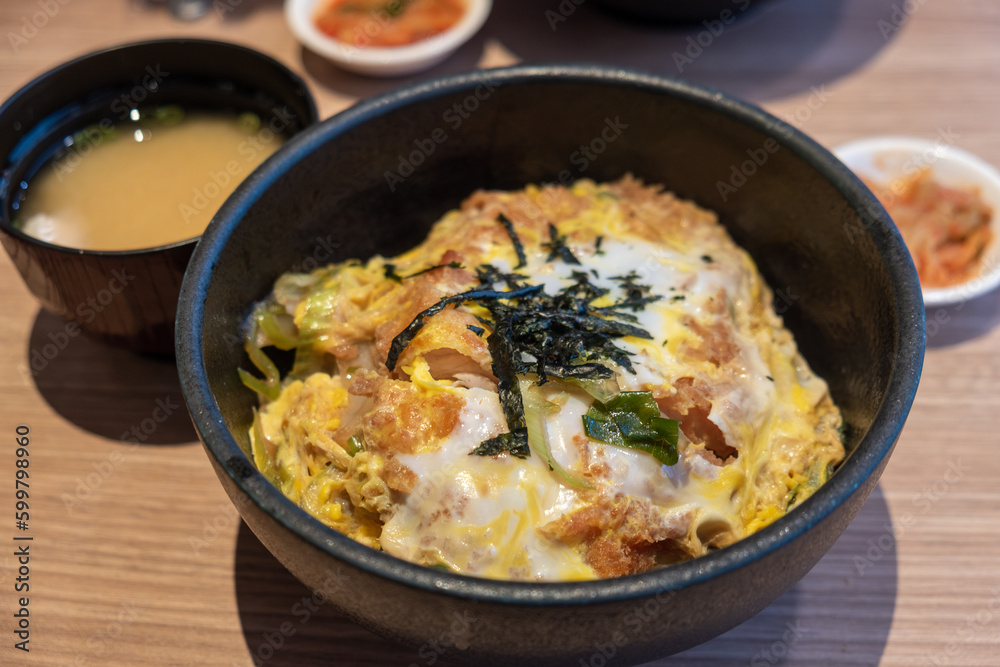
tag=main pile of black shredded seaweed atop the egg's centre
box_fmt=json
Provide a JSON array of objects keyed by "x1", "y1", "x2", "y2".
[{"x1": 386, "y1": 250, "x2": 659, "y2": 458}]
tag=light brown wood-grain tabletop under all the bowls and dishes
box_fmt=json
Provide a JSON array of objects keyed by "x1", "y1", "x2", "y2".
[{"x1": 0, "y1": 0, "x2": 1000, "y2": 667}]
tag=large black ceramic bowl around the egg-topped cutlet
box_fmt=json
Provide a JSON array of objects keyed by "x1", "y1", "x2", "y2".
[{"x1": 177, "y1": 66, "x2": 924, "y2": 665}]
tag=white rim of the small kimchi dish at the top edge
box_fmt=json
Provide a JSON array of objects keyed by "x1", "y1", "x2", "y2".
[{"x1": 285, "y1": 0, "x2": 493, "y2": 76}]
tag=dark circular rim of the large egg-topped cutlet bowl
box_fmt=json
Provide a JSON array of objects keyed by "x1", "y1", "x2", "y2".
[{"x1": 176, "y1": 65, "x2": 925, "y2": 606}]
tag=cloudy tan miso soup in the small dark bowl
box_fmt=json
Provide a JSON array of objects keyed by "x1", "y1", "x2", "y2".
[{"x1": 15, "y1": 107, "x2": 284, "y2": 250}]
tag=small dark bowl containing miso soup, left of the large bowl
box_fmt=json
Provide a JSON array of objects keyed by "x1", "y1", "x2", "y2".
[{"x1": 0, "y1": 39, "x2": 317, "y2": 354}]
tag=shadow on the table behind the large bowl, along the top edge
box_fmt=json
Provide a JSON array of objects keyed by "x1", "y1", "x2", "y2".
[{"x1": 302, "y1": 0, "x2": 908, "y2": 105}]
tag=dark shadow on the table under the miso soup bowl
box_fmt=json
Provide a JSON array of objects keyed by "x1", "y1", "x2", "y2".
[{"x1": 18, "y1": 310, "x2": 198, "y2": 445}]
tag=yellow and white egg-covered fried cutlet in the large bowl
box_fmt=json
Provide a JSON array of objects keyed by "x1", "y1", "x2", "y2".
[{"x1": 242, "y1": 177, "x2": 844, "y2": 581}]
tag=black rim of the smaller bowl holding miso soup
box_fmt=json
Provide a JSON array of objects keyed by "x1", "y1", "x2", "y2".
[{"x1": 0, "y1": 37, "x2": 319, "y2": 257}]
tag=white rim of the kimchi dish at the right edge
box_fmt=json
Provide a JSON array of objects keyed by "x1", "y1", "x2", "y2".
[{"x1": 832, "y1": 135, "x2": 1000, "y2": 308}]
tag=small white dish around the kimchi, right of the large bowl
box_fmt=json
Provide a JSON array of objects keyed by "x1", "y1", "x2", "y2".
[{"x1": 833, "y1": 139, "x2": 1000, "y2": 308}]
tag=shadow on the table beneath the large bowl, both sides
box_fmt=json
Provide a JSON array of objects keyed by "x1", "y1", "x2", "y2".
[{"x1": 235, "y1": 487, "x2": 897, "y2": 667}]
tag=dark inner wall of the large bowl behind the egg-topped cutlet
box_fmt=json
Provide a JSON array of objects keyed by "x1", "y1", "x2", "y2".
[{"x1": 193, "y1": 73, "x2": 912, "y2": 460}]
